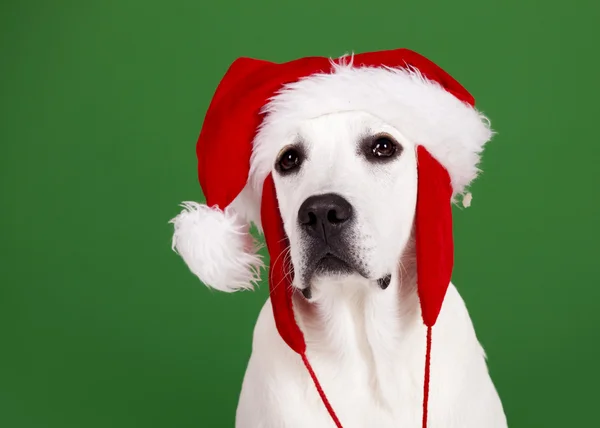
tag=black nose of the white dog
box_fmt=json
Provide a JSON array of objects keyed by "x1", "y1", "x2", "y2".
[{"x1": 298, "y1": 193, "x2": 352, "y2": 243}]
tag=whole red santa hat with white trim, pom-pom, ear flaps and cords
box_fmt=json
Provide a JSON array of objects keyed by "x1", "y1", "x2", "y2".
[{"x1": 172, "y1": 49, "x2": 492, "y2": 427}]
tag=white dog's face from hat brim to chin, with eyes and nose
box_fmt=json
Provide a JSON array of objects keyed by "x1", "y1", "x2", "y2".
[{"x1": 264, "y1": 112, "x2": 417, "y2": 295}]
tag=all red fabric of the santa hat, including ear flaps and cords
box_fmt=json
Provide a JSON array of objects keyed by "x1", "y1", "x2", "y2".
[{"x1": 196, "y1": 49, "x2": 474, "y2": 427}]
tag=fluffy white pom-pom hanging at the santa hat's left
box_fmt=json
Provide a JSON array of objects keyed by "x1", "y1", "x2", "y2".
[{"x1": 171, "y1": 202, "x2": 263, "y2": 293}]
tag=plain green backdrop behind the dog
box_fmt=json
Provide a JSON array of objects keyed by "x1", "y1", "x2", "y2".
[{"x1": 0, "y1": 0, "x2": 600, "y2": 428}]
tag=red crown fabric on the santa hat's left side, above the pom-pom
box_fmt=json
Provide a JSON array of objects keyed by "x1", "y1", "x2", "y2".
[{"x1": 196, "y1": 58, "x2": 330, "y2": 209}]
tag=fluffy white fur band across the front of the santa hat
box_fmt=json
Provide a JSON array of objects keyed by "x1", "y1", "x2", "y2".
[{"x1": 251, "y1": 60, "x2": 493, "y2": 195}]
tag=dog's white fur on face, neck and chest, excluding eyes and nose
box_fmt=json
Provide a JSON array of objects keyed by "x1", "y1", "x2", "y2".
[{"x1": 236, "y1": 112, "x2": 507, "y2": 428}]
